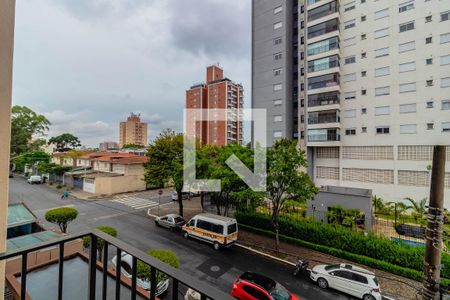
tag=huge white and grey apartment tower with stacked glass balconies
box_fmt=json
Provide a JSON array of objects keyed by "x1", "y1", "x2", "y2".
[{"x1": 252, "y1": 0, "x2": 450, "y2": 205}]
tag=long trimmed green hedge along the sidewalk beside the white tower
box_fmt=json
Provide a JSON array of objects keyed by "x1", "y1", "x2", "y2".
[{"x1": 235, "y1": 212, "x2": 450, "y2": 280}]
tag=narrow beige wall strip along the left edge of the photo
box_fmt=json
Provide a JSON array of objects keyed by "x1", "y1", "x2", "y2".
[{"x1": 0, "y1": 0, "x2": 15, "y2": 299}]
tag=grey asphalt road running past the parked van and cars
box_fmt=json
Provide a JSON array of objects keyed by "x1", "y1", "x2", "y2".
[{"x1": 9, "y1": 177, "x2": 353, "y2": 300}]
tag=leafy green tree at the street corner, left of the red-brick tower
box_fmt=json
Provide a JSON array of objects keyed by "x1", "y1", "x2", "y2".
[{"x1": 144, "y1": 129, "x2": 183, "y2": 216}]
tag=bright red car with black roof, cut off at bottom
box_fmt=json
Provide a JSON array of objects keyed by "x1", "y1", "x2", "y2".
[{"x1": 231, "y1": 272, "x2": 299, "y2": 300}]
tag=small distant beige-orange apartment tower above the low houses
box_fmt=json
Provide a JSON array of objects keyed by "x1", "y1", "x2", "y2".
[{"x1": 119, "y1": 113, "x2": 148, "y2": 148}]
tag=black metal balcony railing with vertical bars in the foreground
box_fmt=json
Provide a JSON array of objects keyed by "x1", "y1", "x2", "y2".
[{"x1": 0, "y1": 229, "x2": 233, "y2": 300}]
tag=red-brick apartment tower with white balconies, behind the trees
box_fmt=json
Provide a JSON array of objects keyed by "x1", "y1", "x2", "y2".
[{"x1": 185, "y1": 65, "x2": 244, "y2": 145}]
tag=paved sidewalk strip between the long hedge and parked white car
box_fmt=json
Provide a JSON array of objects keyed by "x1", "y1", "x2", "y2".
[{"x1": 239, "y1": 230, "x2": 421, "y2": 300}]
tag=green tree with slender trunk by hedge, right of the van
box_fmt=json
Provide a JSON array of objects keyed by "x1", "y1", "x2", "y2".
[{"x1": 267, "y1": 139, "x2": 318, "y2": 250}]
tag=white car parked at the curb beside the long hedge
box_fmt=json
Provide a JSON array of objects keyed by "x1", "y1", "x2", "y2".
[{"x1": 311, "y1": 264, "x2": 382, "y2": 300}]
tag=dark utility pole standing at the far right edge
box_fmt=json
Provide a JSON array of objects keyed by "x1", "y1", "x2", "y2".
[{"x1": 422, "y1": 146, "x2": 445, "y2": 300}]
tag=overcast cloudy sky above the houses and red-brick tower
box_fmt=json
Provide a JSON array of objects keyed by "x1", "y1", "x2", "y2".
[{"x1": 13, "y1": 0, "x2": 251, "y2": 146}]
